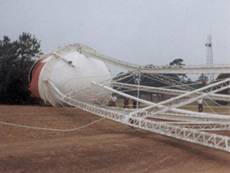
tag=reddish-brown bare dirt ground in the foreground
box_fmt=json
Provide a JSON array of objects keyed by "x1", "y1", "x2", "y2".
[{"x1": 0, "y1": 106, "x2": 230, "y2": 173}]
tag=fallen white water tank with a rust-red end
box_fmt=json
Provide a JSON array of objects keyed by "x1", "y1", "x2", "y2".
[{"x1": 30, "y1": 44, "x2": 112, "y2": 106}]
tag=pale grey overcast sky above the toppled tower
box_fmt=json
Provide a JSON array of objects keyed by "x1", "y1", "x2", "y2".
[{"x1": 0, "y1": 0, "x2": 230, "y2": 65}]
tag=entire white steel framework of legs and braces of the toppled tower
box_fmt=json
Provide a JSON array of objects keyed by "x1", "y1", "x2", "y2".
[{"x1": 35, "y1": 44, "x2": 230, "y2": 152}]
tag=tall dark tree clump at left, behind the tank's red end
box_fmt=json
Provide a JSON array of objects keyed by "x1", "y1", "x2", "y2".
[{"x1": 0, "y1": 33, "x2": 40, "y2": 104}]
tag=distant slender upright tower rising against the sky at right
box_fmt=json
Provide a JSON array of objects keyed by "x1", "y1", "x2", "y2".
[{"x1": 205, "y1": 35, "x2": 214, "y2": 81}]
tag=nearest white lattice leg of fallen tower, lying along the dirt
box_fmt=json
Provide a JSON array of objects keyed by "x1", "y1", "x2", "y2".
[{"x1": 49, "y1": 82, "x2": 230, "y2": 152}]
